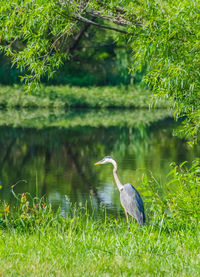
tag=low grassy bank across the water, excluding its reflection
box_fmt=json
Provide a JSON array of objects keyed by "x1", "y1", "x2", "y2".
[{"x1": 0, "y1": 86, "x2": 168, "y2": 109}]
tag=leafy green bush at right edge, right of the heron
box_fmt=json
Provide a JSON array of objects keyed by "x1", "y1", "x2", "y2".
[{"x1": 167, "y1": 159, "x2": 200, "y2": 221}]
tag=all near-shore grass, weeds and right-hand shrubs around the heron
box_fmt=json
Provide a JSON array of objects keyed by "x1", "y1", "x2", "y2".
[{"x1": 0, "y1": 160, "x2": 200, "y2": 276}]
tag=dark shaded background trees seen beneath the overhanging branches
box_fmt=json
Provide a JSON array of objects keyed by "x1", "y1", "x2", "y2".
[{"x1": 0, "y1": 26, "x2": 142, "y2": 86}]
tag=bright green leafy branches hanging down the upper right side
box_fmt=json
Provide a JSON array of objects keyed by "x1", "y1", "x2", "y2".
[{"x1": 126, "y1": 0, "x2": 200, "y2": 140}]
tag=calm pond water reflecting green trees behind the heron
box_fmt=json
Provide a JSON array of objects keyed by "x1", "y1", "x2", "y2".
[{"x1": 0, "y1": 110, "x2": 200, "y2": 212}]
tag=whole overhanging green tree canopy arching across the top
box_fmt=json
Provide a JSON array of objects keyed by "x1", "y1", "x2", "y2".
[{"x1": 0, "y1": 0, "x2": 200, "y2": 137}]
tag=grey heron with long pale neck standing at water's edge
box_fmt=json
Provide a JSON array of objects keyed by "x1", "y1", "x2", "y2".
[{"x1": 95, "y1": 156, "x2": 145, "y2": 225}]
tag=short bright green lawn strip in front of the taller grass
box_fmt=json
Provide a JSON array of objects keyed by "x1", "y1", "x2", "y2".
[{"x1": 0, "y1": 222, "x2": 200, "y2": 276}]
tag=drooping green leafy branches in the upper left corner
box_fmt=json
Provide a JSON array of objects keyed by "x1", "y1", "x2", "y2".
[{"x1": 0, "y1": 0, "x2": 73, "y2": 88}]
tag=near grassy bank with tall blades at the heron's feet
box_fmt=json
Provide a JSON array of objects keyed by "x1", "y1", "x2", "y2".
[{"x1": 0, "y1": 197, "x2": 200, "y2": 276}]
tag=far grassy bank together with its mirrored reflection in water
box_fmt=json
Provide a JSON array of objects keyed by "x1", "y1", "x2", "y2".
[{"x1": 0, "y1": 86, "x2": 173, "y2": 129}]
